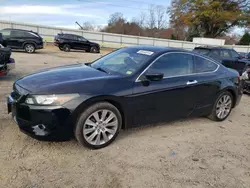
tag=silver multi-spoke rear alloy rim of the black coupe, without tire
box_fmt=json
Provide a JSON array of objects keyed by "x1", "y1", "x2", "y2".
[{"x1": 216, "y1": 95, "x2": 232, "y2": 119}]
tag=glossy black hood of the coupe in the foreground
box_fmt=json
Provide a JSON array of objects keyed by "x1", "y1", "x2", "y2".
[{"x1": 16, "y1": 64, "x2": 117, "y2": 93}]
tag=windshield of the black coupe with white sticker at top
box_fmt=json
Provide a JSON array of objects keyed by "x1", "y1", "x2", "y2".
[{"x1": 91, "y1": 48, "x2": 154, "y2": 75}]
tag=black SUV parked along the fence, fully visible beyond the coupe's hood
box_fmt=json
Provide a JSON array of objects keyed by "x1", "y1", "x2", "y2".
[{"x1": 54, "y1": 33, "x2": 100, "y2": 53}]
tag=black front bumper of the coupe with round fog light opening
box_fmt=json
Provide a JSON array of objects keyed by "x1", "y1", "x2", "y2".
[{"x1": 7, "y1": 95, "x2": 73, "y2": 141}]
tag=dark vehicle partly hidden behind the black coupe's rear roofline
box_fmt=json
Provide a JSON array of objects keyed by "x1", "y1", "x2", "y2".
[{"x1": 194, "y1": 46, "x2": 250, "y2": 75}]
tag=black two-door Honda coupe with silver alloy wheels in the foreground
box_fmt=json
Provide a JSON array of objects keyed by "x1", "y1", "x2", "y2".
[{"x1": 8, "y1": 46, "x2": 242, "y2": 149}]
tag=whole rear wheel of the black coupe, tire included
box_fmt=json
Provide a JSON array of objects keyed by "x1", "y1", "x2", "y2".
[{"x1": 208, "y1": 91, "x2": 233, "y2": 121}]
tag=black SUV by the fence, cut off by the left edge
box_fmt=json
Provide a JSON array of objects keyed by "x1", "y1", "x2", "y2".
[{"x1": 0, "y1": 29, "x2": 43, "y2": 53}]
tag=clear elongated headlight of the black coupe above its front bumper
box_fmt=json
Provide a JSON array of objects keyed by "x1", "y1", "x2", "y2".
[{"x1": 25, "y1": 94, "x2": 79, "y2": 105}]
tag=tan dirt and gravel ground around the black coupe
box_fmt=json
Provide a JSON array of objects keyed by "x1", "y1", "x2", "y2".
[{"x1": 0, "y1": 47, "x2": 250, "y2": 188}]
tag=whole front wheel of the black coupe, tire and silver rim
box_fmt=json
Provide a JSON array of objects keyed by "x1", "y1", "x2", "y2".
[{"x1": 74, "y1": 102, "x2": 122, "y2": 149}]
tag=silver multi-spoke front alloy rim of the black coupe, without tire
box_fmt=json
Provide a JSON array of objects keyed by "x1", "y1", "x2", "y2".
[{"x1": 83, "y1": 109, "x2": 118, "y2": 146}]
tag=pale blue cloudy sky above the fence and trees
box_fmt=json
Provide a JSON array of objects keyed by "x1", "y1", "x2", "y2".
[{"x1": 0, "y1": 0, "x2": 170, "y2": 28}]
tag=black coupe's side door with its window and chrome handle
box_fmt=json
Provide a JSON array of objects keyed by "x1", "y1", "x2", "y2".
[{"x1": 133, "y1": 52, "x2": 197, "y2": 124}]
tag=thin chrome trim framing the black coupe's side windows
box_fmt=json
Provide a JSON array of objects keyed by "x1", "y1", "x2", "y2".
[{"x1": 135, "y1": 52, "x2": 220, "y2": 82}]
